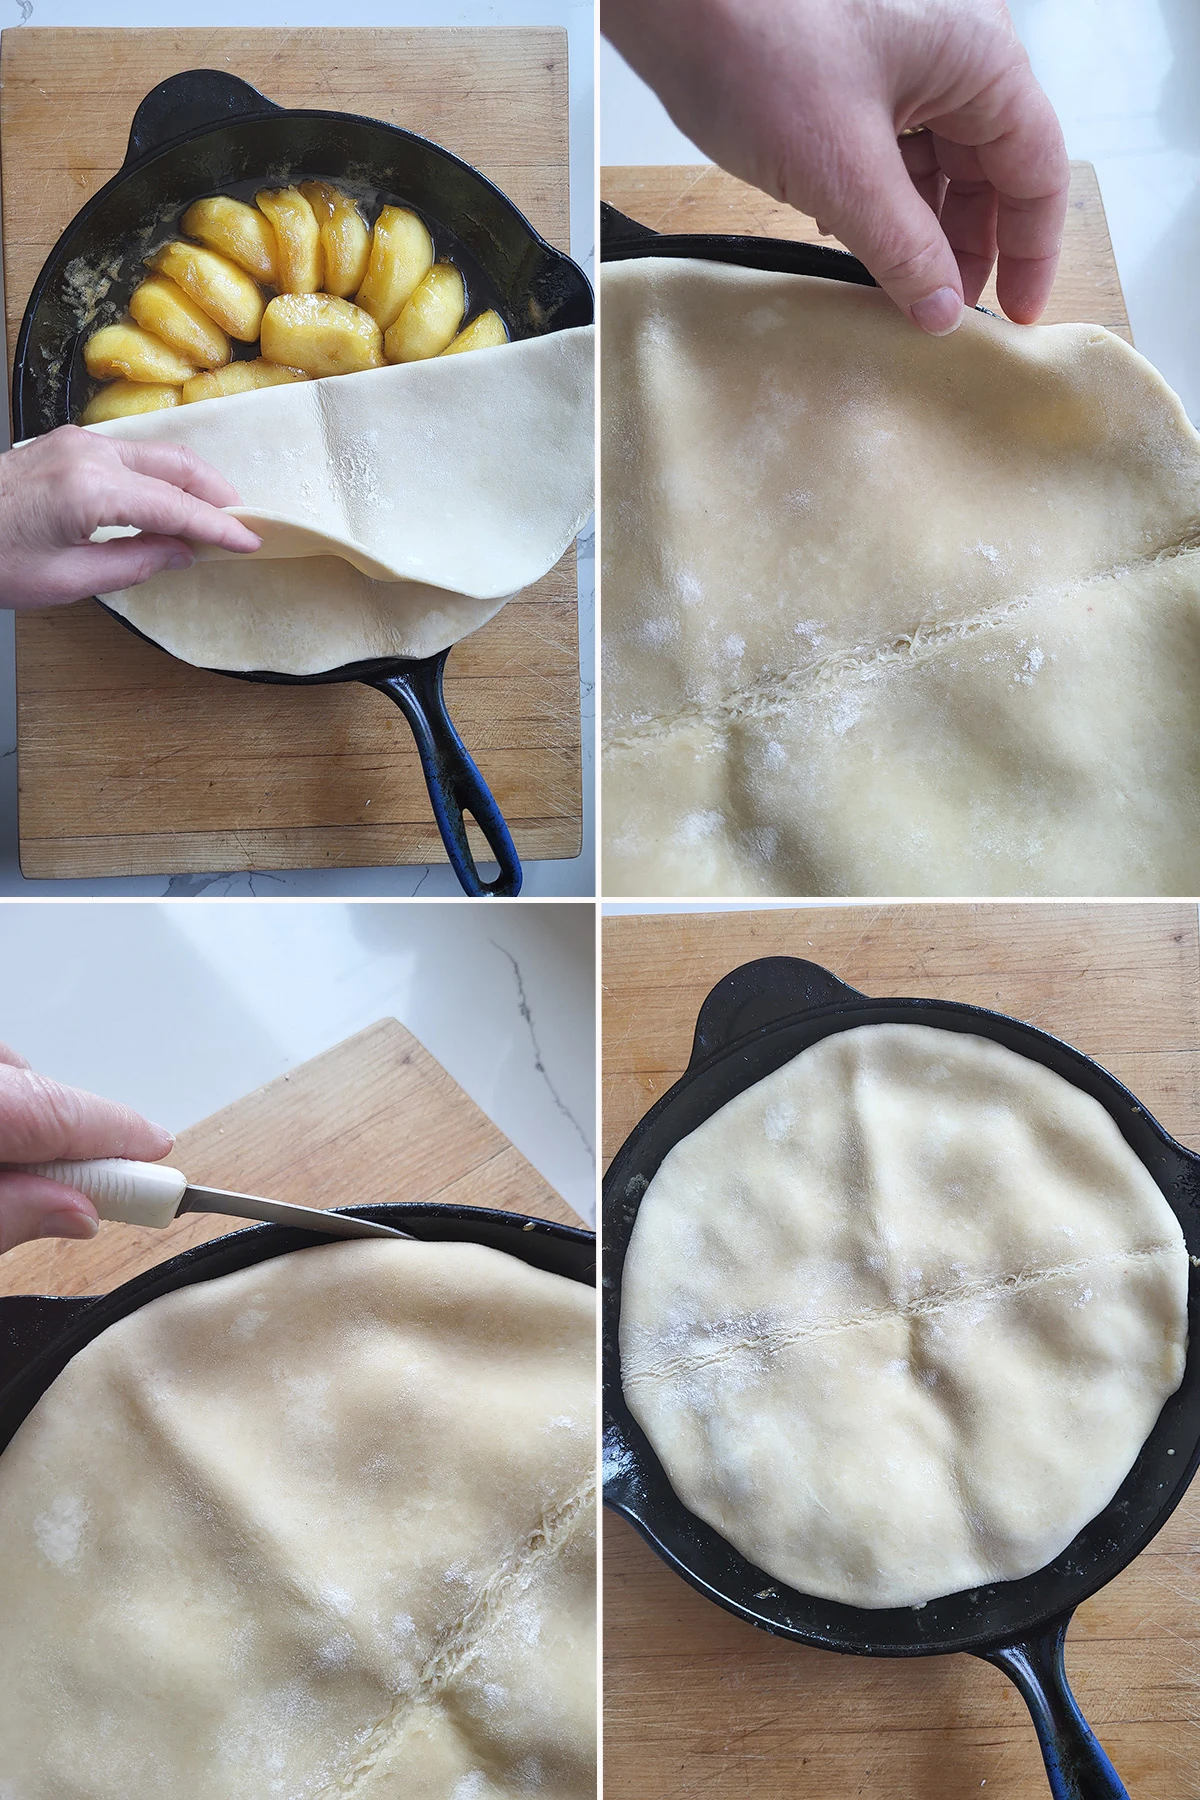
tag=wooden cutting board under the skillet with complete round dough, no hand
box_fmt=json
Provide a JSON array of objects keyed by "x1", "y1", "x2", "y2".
[{"x1": 603, "y1": 904, "x2": 1200, "y2": 1800}]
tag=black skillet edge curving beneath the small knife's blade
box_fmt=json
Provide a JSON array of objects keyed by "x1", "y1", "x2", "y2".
[{"x1": 0, "y1": 1204, "x2": 596, "y2": 1451}]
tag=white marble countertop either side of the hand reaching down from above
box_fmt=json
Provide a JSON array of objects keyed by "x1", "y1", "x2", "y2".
[{"x1": 599, "y1": 0, "x2": 1200, "y2": 423}]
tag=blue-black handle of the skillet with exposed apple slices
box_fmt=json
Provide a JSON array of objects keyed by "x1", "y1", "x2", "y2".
[{"x1": 363, "y1": 650, "x2": 522, "y2": 898}]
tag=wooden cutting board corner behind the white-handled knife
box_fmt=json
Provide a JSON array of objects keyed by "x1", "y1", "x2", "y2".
[{"x1": 0, "y1": 1019, "x2": 581, "y2": 1294}]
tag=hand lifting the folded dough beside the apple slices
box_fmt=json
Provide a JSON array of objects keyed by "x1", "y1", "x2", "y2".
[{"x1": 0, "y1": 425, "x2": 261, "y2": 608}]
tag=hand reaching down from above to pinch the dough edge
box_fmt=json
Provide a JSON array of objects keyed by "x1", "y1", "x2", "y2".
[{"x1": 603, "y1": 0, "x2": 1069, "y2": 337}]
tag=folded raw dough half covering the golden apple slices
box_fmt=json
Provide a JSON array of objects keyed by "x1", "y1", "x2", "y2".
[{"x1": 86, "y1": 326, "x2": 594, "y2": 675}]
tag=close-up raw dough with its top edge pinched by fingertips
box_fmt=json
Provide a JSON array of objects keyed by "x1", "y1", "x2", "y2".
[{"x1": 603, "y1": 259, "x2": 1200, "y2": 895}]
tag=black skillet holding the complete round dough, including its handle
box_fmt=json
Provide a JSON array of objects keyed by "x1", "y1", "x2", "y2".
[{"x1": 603, "y1": 956, "x2": 1200, "y2": 1800}]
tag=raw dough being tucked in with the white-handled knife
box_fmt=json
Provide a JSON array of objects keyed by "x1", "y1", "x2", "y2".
[{"x1": 0, "y1": 1242, "x2": 596, "y2": 1800}]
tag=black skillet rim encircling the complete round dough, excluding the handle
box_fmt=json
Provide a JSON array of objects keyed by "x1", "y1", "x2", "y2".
[{"x1": 601, "y1": 958, "x2": 1200, "y2": 1656}]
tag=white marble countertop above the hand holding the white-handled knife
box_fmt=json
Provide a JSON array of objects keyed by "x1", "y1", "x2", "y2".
[{"x1": 0, "y1": 900, "x2": 596, "y2": 1224}]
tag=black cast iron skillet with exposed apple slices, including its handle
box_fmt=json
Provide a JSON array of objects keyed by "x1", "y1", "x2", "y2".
[{"x1": 13, "y1": 68, "x2": 592, "y2": 895}]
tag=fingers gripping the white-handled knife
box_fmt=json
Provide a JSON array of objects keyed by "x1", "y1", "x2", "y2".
[{"x1": 0, "y1": 1044, "x2": 175, "y2": 1253}]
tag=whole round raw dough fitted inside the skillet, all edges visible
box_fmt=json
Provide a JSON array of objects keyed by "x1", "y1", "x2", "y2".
[{"x1": 621, "y1": 1024, "x2": 1187, "y2": 1607}]
